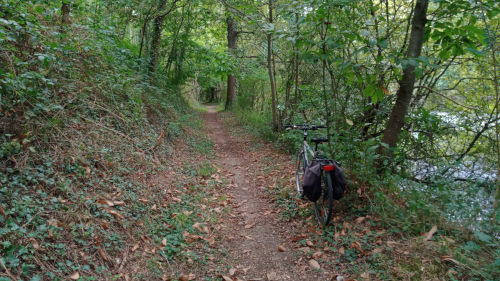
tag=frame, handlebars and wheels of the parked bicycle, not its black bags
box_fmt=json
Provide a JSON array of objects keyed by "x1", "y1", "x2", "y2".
[{"x1": 284, "y1": 123, "x2": 335, "y2": 226}]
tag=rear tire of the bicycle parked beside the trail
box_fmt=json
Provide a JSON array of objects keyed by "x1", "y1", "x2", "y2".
[{"x1": 314, "y1": 168, "x2": 333, "y2": 226}]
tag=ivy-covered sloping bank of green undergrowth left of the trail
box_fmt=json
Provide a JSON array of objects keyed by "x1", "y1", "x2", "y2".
[{"x1": 0, "y1": 1, "x2": 223, "y2": 281}]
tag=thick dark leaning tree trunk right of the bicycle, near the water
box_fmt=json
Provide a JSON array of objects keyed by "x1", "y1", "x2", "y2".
[{"x1": 380, "y1": 0, "x2": 429, "y2": 149}]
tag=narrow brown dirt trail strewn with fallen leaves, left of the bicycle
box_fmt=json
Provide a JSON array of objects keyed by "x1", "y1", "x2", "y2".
[{"x1": 203, "y1": 106, "x2": 329, "y2": 280}]
